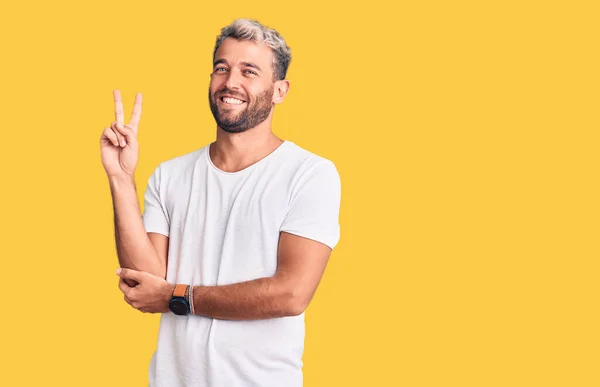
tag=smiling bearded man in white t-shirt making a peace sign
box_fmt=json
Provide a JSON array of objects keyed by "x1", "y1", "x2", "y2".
[{"x1": 101, "y1": 19, "x2": 341, "y2": 387}]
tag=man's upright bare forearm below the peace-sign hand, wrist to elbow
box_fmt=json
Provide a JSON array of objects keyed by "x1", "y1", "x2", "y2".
[{"x1": 109, "y1": 176, "x2": 166, "y2": 278}]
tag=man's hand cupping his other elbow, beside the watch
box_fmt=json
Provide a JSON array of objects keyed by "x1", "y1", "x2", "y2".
[{"x1": 117, "y1": 268, "x2": 175, "y2": 313}]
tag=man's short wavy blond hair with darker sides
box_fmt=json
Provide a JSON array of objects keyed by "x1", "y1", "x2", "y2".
[{"x1": 213, "y1": 19, "x2": 292, "y2": 81}]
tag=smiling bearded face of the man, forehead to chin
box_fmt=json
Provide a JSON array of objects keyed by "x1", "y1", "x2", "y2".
[{"x1": 208, "y1": 38, "x2": 278, "y2": 133}]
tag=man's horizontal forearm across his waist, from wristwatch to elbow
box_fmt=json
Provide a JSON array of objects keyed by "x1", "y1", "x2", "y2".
[{"x1": 192, "y1": 277, "x2": 305, "y2": 320}]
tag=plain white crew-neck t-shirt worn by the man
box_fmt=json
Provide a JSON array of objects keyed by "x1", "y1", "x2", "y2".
[{"x1": 138, "y1": 141, "x2": 341, "y2": 387}]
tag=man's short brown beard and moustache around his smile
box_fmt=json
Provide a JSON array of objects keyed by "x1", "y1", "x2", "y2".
[{"x1": 208, "y1": 86, "x2": 274, "y2": 133}]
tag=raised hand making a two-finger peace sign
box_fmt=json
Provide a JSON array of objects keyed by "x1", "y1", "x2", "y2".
[{"x1": 100, "y1": 90, "x2": 142, "y2": 177}]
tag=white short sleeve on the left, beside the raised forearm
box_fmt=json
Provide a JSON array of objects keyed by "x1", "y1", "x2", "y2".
[{"x1": 142, "y1": 166, "x2": 169, "y2": 236}]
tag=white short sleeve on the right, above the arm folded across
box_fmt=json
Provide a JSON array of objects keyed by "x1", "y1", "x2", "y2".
[{"x1": 280, "y1": 159, "x2": 341, "y2": 249}]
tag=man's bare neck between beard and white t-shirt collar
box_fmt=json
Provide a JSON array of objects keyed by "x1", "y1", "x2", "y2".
[{"x1": 210, "y1": 120, "x2": 283, "y2": 172}]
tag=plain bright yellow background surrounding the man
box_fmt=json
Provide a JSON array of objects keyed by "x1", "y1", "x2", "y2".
[{"x1": 0, "y1": 0, "x2": 600, "y2": 387}]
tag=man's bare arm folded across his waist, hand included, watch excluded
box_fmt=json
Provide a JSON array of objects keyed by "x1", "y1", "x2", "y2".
[{"x1": 117, "y1": 232, "x2": 331, "y2": 320}]
